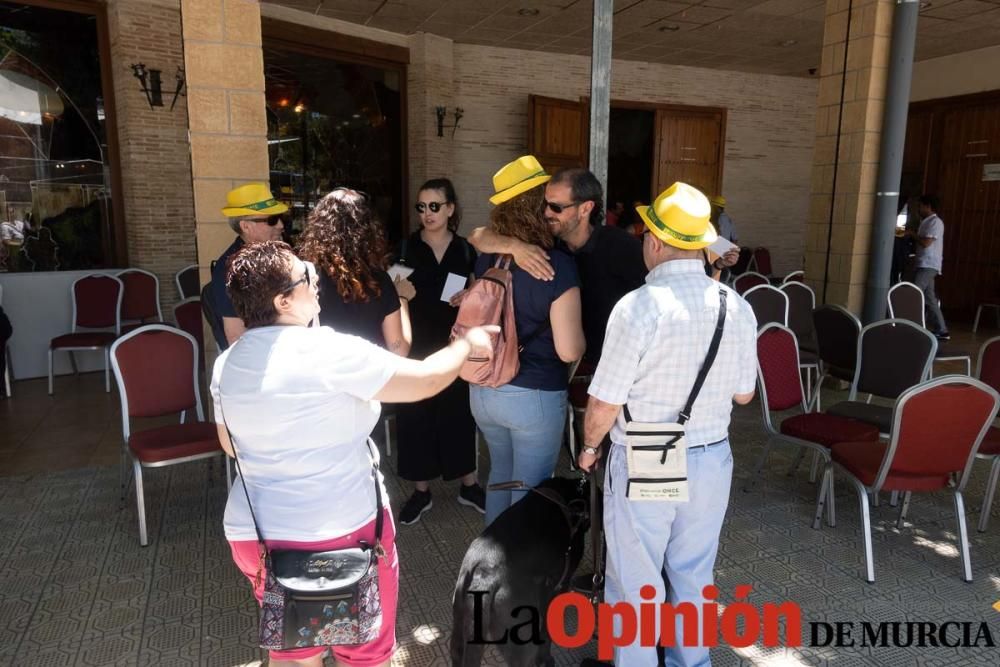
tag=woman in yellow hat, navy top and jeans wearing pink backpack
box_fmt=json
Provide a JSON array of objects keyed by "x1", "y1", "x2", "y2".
[{"x1": 469, "y1": 155, "x2": 586, "y2": 525}]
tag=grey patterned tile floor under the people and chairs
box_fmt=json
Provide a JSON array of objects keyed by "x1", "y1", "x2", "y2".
[{"x1": 0, "y1": 334, "x2": 1000, "y2": 667}]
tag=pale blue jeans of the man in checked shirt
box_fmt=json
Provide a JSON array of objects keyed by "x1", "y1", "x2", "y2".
[{"x1": 604, "y1": 440, "x2": 736, "y2": 667}]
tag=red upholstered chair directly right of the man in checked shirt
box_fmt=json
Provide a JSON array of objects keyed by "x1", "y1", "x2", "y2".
[{"x1": 743, "y1": 324, "x2": 878, "y2": 527}]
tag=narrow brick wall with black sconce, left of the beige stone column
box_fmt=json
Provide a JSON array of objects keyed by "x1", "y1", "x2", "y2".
[{"x1": 108, "y1": 0, "x2": 196, "y2": 319}]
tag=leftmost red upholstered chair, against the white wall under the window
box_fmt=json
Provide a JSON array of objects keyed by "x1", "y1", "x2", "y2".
[{"x1": 49, "y1": 273, "x2": 125, "y2": 396}]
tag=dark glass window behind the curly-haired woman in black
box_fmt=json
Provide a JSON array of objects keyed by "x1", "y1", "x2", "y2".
[{"x1": 264, "y1": 42, "x2": 405, "y2": 248}]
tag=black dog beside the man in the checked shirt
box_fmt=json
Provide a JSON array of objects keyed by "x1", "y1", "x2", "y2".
[{"x1": 451, "y1": 477, "x2": 590, "y2": 667}]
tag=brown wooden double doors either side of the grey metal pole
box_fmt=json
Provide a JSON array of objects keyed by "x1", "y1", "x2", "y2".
[{"x1": 528, "y1": 95, "x2": 726, "y2": 201}]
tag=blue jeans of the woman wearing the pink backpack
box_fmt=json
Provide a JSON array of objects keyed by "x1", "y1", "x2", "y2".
[{"x1": 469, "y1": 384, "x2": 566, "y2": 526}]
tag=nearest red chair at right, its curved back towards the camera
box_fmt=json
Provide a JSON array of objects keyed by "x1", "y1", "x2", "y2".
[{"x1": 816, "y1": 375, "x2": 1000, "y2": 583}]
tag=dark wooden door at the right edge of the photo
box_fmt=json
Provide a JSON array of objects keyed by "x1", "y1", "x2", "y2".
[{"x1": 929, "y1": 99, "x2": 1000, "y2": 314}]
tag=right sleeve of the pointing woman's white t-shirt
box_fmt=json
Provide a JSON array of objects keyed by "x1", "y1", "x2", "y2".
[{"x1": 315, "y1": 327, "x2": 401, "y2": 401}]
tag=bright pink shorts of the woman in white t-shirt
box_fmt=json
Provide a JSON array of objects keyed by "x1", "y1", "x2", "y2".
[{"x1": 229, "y1": 509, "x2": 399, "y2": 667}]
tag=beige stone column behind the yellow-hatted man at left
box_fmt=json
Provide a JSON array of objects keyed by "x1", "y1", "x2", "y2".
[{"x1": 181, "y1": 0, "x2": 269, "y2": 284}]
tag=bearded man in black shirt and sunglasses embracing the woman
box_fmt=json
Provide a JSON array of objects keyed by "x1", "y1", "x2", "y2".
[{"x1": 469, "y1": 168, "x2": 646, "y2": 364}]
